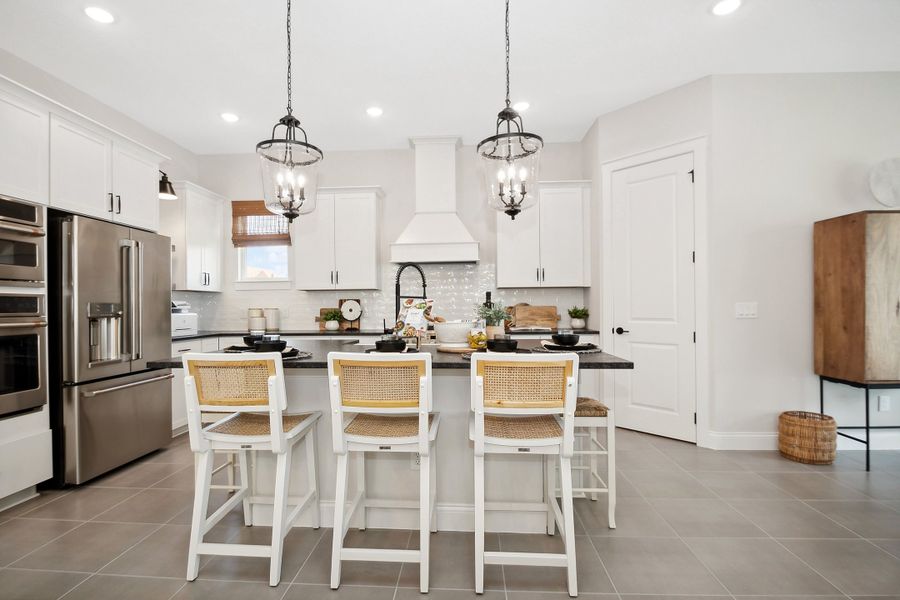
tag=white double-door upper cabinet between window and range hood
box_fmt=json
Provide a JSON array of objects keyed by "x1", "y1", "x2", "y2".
[{"x1": 292, "y1": 188, "x2": 381, "y2": 290}]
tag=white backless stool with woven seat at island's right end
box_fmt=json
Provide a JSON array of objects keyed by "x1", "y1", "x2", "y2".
[{"x1": 572, "y1": 397, "x2": 616, "y2": 529}]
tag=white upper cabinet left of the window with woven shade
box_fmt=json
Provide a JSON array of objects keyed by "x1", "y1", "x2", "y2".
[{"x1": 159, "y1": 181, "x2": 225, "y2": 292}]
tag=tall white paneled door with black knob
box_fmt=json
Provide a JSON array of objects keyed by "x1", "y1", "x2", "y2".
[{"x1": 607, "y1": 153, "x2": 696, "y2": 442}]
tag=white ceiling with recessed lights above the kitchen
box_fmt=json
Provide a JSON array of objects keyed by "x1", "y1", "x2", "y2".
[{"x1": 0, "y1": 0, "x2": 900, "y2": 154}]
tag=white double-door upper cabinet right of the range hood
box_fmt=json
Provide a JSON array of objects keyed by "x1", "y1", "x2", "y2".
[{"x1": 497, "y1": 181, "x2": 591, "y2": 288}]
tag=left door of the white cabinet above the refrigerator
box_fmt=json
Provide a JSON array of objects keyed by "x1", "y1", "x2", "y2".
[{"x1": 50, "y1": 115, "x2": 115, "y2": 221}]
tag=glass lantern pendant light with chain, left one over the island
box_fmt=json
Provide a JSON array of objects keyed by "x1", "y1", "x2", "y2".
[{"x1": 256, "y1": 0, "x2": 324, "y2": 222}]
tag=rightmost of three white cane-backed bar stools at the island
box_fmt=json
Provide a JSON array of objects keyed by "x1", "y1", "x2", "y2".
[{"x1": 469, "y1": 353, "x2": 578, "y2": 598}]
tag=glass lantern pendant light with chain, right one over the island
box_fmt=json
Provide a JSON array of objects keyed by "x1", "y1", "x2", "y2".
[{"x1": 476, "y1": 0, "x2": 544, "y2": 220}]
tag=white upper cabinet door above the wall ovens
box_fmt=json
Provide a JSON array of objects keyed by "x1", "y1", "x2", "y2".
[{"x1": 0, "y1": 90, "x2": 50, "y2": 204}]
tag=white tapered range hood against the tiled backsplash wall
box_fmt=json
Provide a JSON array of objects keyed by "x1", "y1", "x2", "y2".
[{"x1": 391, "y1": 137, "x2": 478, "y2": 263}]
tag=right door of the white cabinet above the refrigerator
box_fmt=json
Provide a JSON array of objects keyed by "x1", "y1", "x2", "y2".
[{"x1": 113, "y1": 142, "x2": 159, "y2": 231}]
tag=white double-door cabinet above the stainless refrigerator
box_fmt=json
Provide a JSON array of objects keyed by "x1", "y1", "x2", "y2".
[{"x1": 50, "y1": 114, "x2": 159, "y2": 231}]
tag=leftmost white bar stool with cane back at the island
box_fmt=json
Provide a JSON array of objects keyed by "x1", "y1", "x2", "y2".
[{"x1": 183, "y1": 352, "x2": 321, "y2": 586}]
